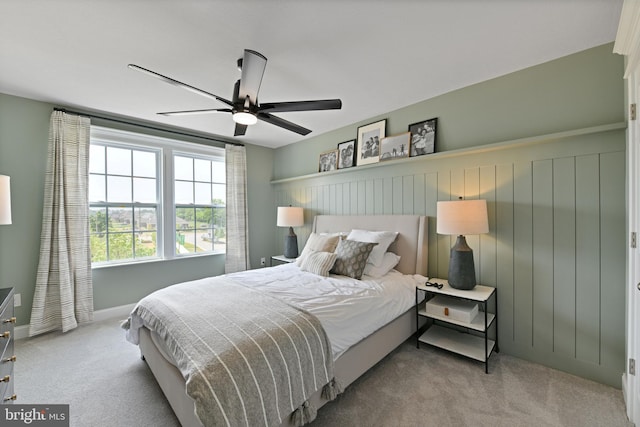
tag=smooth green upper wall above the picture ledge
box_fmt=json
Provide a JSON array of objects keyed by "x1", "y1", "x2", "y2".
[{"x1": 273, "y1": 44, "x2": 624, "y2": 179}]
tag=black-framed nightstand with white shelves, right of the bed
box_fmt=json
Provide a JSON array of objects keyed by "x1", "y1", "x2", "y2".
[{"x1": 416, "y1": 279, "x2": 500, "y2": 374}]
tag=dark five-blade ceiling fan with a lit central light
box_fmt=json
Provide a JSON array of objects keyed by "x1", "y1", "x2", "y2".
[{"x1": 128, "y1": 49, "x2": 342, "y2": 136}]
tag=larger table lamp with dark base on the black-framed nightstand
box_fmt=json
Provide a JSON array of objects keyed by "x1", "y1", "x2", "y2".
[{"x1": 436, "y1": 198, "x2": 489, "y2": 290}]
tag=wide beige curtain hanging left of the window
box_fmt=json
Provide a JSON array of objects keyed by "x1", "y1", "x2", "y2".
[{"x1": 29, "y1": 111, "x2": 93, "y2": 336}]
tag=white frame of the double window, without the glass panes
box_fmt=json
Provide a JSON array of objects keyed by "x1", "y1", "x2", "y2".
[{"x1": 87, "y1": 125, "x2": 226, "y2": 268}]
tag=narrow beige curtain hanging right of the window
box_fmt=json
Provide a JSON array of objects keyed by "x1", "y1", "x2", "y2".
[{"x1": 225, "y1": 144, "x2": 251, "y2": 273}]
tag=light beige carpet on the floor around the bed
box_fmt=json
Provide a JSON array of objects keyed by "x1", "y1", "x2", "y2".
[{"x1": 15, "y1": 320, "x2": 632, "y2": 427}]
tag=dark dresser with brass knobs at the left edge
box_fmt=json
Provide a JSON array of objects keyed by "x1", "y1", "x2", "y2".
[{"x1": 0, "y1": 288, "x2": 16, "y2": 404}]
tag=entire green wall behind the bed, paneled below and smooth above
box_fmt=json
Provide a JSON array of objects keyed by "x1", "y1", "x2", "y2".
[{"x1": 272, "y1": 45, "x2": 626, "y2": 388}]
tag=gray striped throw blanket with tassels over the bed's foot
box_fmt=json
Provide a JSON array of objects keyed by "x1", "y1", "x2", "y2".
[{"x1": 125, "y1": 276, "x2": 339, "y2": 427}]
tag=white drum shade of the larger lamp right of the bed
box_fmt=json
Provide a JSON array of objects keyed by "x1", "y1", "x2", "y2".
[{"x1": 436, "y1": 200, "x2": 489, "y2": 236}]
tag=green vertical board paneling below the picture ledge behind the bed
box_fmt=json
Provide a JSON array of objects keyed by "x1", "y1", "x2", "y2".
[{"x1": 273, "y1": 129, "x2": 625, "y2": 387}]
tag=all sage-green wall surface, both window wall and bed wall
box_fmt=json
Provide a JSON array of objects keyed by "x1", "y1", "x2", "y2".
[{"x1": 0, "y1": 44, "x2": 626, "y2": 387}]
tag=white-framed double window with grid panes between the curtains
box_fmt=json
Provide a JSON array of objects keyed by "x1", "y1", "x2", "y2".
[{"x1": 89, "y1": 126, "x2": 226, "y2": 266}]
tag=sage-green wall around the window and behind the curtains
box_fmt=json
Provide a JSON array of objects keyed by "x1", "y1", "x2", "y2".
[{"x1": 0, "y1": 94, "x2": 276, "y2": 318}]
